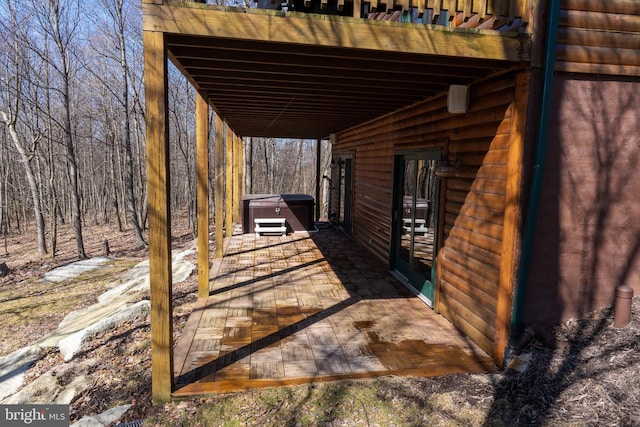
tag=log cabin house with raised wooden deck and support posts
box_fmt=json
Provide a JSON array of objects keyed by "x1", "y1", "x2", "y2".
[{"x1": 143, "y1": 0, "x2": 640, "y2": 401}]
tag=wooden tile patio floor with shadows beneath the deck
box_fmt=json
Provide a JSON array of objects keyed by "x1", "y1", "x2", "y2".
[{"x1": 173, "y1": 224, "x2": 495, "y2": 396}]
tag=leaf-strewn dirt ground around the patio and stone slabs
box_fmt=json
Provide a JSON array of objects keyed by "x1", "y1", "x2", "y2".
[{"x1": 0, "y1": 221, "x2": 640, "y2": 426}]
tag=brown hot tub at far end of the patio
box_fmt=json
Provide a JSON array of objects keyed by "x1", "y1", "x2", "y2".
[{"x1": 242, "y1": 194, "x2": 315, "y2": 233}]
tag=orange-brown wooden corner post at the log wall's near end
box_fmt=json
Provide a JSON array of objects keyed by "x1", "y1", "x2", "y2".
[{"x1": 492, "y1": 72, "x2": 530, "y2": 366}]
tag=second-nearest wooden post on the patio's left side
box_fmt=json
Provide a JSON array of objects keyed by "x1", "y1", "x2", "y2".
[{"x1": 196, "y1": 92, "x2": 209, "y2": 298}]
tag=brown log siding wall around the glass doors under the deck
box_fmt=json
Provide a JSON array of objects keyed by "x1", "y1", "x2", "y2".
[{"x1": 333, "y1": 74, "x2": 515, "y2": 354}]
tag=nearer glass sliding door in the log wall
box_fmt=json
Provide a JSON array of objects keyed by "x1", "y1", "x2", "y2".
[{"x1": 391, "y1": 149, "x2": 440, "y2": 306}]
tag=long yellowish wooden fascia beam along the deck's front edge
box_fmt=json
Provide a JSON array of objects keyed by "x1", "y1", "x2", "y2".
[{"x1": 143, "y1": 3, "x2": 530, "y2": 62}]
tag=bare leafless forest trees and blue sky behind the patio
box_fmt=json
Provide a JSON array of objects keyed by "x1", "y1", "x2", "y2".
[{"x1": 0, "y1": 0, "x2": 330, "y2": 258}]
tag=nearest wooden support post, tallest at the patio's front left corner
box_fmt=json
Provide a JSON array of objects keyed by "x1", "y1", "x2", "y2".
[{"x1": 143, "y1": 31, "x2": 174, "y2": 403}]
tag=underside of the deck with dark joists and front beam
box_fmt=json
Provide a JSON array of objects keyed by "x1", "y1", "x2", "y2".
[{"x1": 143, "y1": 0, "x2": 530, "y2": 138}]
